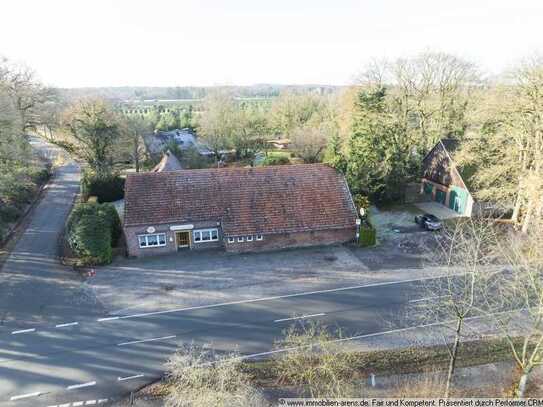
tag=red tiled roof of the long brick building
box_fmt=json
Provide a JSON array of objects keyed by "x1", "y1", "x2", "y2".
[{"x1": 124, "y1": 164, "x2": 357, "y2": 236}]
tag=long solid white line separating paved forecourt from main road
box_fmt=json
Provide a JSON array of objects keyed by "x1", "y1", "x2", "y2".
[{"x1": 101, "y1": 274, "x2": 450, "y2": 322}]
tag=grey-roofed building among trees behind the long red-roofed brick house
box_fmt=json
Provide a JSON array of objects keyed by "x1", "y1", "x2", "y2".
[{"x1": 143, "y1": 129, "x2": 213, "y2": 159}]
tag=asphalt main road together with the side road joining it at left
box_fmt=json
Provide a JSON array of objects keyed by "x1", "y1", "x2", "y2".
[{"x1": 0, "y1": 139, "x2": 438, "y2": 406}]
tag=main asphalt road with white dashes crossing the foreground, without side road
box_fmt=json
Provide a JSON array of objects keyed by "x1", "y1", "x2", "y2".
[{"x1": 0, "y1": 276, "x2": 434, "y2": 406}]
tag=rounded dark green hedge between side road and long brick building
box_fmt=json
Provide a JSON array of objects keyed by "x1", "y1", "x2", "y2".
[{"x1": 67, "y1": 203, "x2": 122, "y2": 265}]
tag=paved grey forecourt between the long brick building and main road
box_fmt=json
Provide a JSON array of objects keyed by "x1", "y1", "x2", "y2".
[{"x1": 87, "y1": 226, "x2": 446, "y2": 315}]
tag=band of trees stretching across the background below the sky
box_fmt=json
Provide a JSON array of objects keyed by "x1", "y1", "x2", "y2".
[{"x1": 0, "y1": 52, "x2": 543, "y2": 236}]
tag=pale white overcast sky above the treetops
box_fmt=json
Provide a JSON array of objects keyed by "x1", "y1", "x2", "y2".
[{"x1": 0, "y1": 0, "x2": 543, "y2": 87}]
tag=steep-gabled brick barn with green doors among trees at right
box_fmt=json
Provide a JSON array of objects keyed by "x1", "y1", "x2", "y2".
[{"x1": 421, "y1": 139, "x2": 474, "y2": 216}]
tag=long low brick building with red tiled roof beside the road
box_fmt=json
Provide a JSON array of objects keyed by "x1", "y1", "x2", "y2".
[{"x1": 123, "y1": 164, "x2": 358, "y2": 256}]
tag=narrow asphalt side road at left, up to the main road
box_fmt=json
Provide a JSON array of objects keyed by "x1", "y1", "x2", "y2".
[{"x1": 0, "y1": 146, "x2": 100, "y2": 329}]
